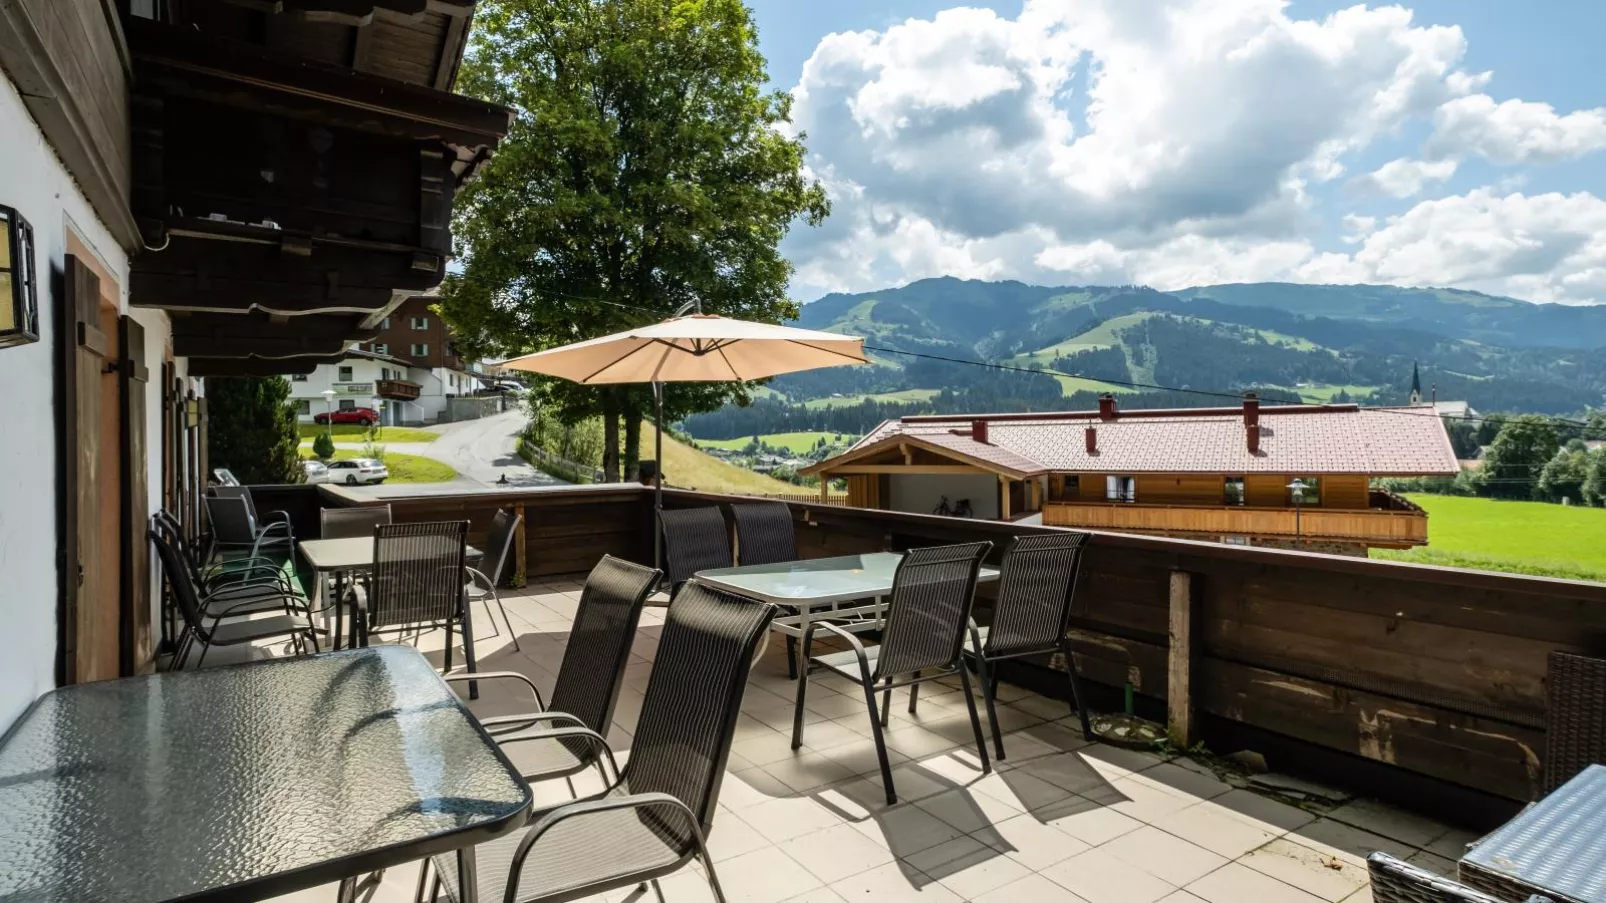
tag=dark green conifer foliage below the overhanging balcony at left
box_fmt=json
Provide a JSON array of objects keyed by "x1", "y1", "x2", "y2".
[{"x1": 206, "y1": 376, "x2": 307, "y2": 484}]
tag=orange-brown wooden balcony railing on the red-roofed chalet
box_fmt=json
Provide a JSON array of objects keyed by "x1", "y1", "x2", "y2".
[{"x1": 1042, "y1": 493, "x2": 1428, "y2": 546}]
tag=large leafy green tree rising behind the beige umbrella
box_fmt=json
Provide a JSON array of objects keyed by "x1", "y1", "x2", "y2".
[{"x1": 440, "y1": 0, "x2": 829, "y2": 479}]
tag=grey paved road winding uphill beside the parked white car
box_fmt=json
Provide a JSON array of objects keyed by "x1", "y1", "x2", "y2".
[{"x1": 339, "y1": 411, "x2": 564, "y2": 498}]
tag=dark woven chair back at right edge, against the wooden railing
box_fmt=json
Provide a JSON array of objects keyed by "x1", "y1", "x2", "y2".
[{"x1": 1540, "y1": 652, "x2": 1606, "y2": 795}]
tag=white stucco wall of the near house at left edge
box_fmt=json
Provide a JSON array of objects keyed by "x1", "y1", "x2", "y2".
[{"x1": 0, "y1": 74, "x2": 170, "y2": 729}]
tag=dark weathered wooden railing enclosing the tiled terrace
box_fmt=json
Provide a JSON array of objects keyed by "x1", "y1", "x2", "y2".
[{"x1": 289, "y1": 484, "x2": 1606, "y2": 826}]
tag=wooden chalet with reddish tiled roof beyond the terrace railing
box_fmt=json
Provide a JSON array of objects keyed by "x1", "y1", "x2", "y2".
[{"x1": 803, "y1": 394, "x2": 1460, "y2": 554}]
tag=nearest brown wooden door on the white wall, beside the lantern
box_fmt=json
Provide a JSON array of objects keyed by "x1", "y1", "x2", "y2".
[{"x1": 56, "y1": 254, "x2": 120, "y2": 683}]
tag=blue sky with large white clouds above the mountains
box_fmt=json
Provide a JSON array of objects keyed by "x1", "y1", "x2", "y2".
[{"x1": 748, "y1": 0, "x2": 1606, "y2": 304}]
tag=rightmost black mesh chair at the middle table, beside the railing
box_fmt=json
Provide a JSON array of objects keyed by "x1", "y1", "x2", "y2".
[{"x1": 957, "y1": 533, "x2": 1094, "y2": 758}]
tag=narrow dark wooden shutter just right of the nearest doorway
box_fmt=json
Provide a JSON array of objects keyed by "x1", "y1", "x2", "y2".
[{"x1": 117, "y1": 317, "x2": 156, "y2": 676}]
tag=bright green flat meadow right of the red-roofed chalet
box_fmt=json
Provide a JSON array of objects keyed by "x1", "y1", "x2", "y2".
[{"x1": 1372, "y1": 493, "x2": 1606, "y2": 582}]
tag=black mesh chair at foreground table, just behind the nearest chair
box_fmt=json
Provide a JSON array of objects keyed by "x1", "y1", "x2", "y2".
[{"x1": 446, "y1": 554, "x2": 663, "y2": 792}]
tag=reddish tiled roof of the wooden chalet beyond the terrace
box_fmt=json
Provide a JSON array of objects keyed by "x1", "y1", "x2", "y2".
[{"x1": 811, "y1": 405, "x2": 1460, "y2": 476}]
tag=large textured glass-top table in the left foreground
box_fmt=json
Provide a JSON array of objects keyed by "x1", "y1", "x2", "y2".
[{"x1": 0, "y1": 646, "x2": 532, "y2": 903}]
